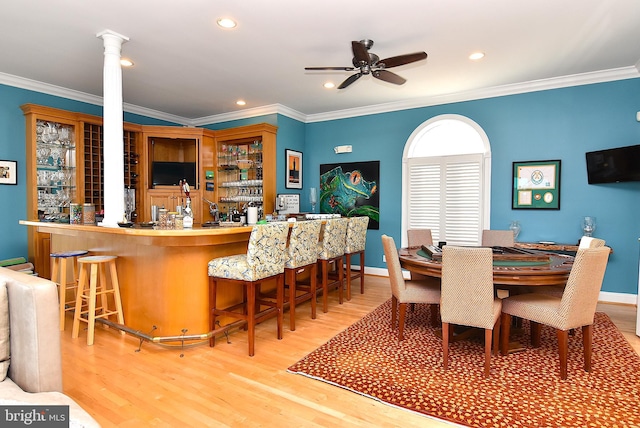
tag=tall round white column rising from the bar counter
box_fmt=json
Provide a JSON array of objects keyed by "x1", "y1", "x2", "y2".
[{"x1": 96, "y1": 30, "x2": 129, "y2": 227}]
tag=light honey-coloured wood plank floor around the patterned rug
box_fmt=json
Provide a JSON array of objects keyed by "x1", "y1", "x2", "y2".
[{"x1": 61, "y1": 276, "x2": 640, "y2": 427}]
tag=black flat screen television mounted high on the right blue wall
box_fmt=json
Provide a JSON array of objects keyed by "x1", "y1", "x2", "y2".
[{"x1": 586, "y1": 145, "x2": 640, "y2": 184}]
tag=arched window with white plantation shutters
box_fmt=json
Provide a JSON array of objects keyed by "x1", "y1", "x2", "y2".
[{"x1": 402, "y1": 115, "x2": 491, "y2": 246}]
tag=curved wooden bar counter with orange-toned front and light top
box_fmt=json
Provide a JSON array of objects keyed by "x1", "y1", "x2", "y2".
[{"x1": 20, "y1": 220, "x2": 252, "y2": 336}]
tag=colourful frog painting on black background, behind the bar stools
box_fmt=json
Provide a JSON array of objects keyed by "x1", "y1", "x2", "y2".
[{"x1": 319, "y1": 161, "x2": 380, "y2": 230}]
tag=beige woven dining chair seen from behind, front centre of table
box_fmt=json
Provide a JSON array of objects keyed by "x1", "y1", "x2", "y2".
[{"x1": 440, "y1": 245, "x2": 502, "y2": 377}]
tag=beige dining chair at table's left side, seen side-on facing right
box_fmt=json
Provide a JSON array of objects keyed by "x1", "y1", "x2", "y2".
[{"x1": 382, "y1": 235, "x2": 440, "y2": 340}]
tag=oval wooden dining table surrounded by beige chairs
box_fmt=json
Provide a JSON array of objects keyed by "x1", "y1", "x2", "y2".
[{"x1": 398, "y1": 247, "x2": 573, "y2": 288}]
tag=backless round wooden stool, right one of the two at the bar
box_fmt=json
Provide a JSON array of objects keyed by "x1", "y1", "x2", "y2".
[{"x1": 71, "y1": 255, "x2": 124, "y2": 345}]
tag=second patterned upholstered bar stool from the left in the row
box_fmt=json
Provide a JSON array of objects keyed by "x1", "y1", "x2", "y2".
[{"x1": 284, "y1": 220, "x2": 322, "y2": 331}]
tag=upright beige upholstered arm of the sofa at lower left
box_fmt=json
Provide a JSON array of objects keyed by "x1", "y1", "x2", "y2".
[{"x1": 0, "y1": 268, "x2": 62, "y2": 392}]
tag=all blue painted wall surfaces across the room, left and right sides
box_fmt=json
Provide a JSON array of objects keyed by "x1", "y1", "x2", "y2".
[{"x1": 0, "y1": 79, "x2": 640, "y2": 294}]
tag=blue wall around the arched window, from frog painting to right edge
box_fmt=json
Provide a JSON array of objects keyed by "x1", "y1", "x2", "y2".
[{"x1": 302, "y1": 79, "x2": 640, "y2": 294}]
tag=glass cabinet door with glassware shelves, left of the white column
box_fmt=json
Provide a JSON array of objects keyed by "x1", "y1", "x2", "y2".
[{"x1": 35, "y1": 119, "x2": 76, "y2": 220}]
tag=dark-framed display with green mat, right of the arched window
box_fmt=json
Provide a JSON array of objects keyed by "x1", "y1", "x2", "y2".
[{"x1": 512, "y1": 160, "x2": 560, "y2": 210}]
